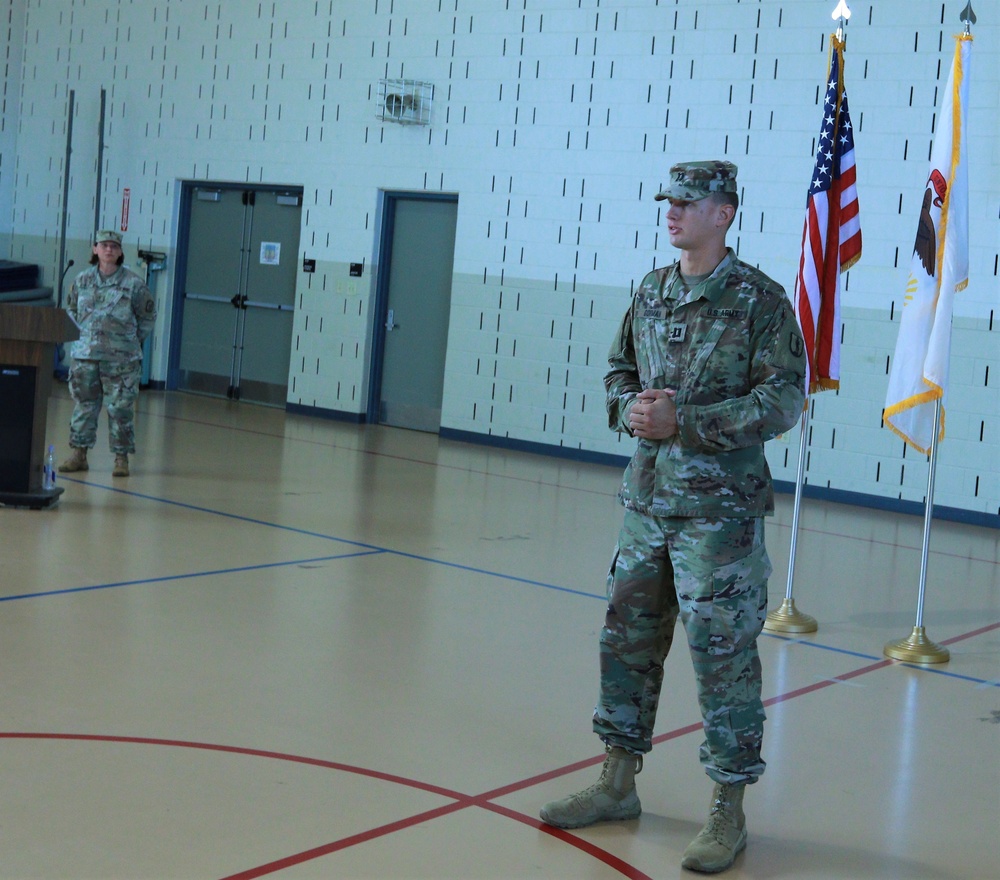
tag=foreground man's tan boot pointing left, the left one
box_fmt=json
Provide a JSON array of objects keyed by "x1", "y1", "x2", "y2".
[{"x1": 539, "y1": 746, "x2": 642, "y2": 828}]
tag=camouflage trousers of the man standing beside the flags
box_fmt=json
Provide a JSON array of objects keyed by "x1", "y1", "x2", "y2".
[{"x1": 594, "y1": 510, "x2": 771, "y2": 783}]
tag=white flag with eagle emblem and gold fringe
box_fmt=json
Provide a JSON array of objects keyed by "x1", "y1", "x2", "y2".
[{"x1": 882, "y1": 34, "x2": 972, "y2": 454}]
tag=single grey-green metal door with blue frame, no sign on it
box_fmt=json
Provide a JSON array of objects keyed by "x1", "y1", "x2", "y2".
[{"x1": 368, "y1": 195, "x2": 458, "y2": 433}]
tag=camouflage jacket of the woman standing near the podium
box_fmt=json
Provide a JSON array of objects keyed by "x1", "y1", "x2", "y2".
[{"x1": 66, "y1": 266, "x2": 156, "y2": 363}]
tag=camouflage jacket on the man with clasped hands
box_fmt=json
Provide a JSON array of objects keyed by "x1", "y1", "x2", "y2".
[{"x1": 604, "y1": 249, "x2": 805, "y2": 517}]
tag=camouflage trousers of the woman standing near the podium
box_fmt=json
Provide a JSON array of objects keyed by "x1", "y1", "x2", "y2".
[{"x1": 69, "y1": 361, "x2": 142, "y2": 455}]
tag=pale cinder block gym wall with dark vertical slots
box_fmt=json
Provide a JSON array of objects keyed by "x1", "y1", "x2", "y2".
[{"x1": 0, "y1": 0, "x2": 1000, "y2": 521}]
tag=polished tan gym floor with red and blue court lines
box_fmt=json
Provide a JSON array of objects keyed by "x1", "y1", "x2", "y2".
[{"x1": 0, "y1": 386, "x2": 1000, "y2": 880}]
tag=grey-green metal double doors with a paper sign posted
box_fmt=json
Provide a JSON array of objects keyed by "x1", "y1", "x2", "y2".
[{"x1": 177, "y1": 185, "x2": 301, "y2": 406}]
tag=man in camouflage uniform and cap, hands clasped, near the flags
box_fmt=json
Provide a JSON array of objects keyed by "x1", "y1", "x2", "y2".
[{"x1": 541, "y1": 161, "x2": 805, "y2": 873}]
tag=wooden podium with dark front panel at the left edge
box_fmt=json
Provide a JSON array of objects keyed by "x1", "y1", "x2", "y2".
[{"x1": 0, "y1": 303, "x2": 80, "y2": 510}]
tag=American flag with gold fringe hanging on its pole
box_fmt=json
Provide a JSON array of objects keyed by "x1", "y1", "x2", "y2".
[{"x1": 794, "y1": 34, "x2": 861, "y2": 394}]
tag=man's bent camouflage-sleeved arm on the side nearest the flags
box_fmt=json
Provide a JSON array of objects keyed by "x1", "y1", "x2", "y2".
[{"x1": 677, "y1": 293, "x2": 806, "y2": 452}]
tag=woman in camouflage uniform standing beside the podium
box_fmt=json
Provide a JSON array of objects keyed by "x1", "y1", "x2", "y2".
[{"x1": 59, "y1": 230, "x2": 156, "y2": 477}]
